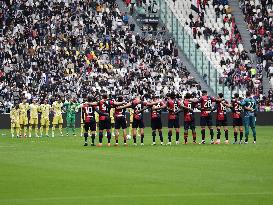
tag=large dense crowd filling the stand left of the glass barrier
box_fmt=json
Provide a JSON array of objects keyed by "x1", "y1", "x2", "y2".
[{"x1": 0, "y1": 0, "x2": 200, "y2": 112}]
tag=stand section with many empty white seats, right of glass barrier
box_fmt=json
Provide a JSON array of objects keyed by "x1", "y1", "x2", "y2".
[{"x1": 163, "y1": 0, "x2": 262, "y2": 93}]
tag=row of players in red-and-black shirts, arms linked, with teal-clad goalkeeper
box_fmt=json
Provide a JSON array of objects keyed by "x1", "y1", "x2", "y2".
[{"x1": 82, "y1": 91, "x2": 257, "y2": 146}]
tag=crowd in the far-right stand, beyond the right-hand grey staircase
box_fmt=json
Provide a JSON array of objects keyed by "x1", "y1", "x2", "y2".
[{"x1": 240, "y1": 0, "x2": 273, "y2": 102}]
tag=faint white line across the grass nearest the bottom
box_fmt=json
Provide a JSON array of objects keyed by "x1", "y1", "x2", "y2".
[{"x1": 0, "y1": 192, "x2": 273, "y2": 202}]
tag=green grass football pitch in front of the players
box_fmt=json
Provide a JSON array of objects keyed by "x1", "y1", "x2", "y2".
[{"x1": 0, "y1": 127, "x2": 273, "y2": 205}]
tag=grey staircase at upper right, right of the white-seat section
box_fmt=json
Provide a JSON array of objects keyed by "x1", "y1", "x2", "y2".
[{"x1": 229, "y1": 0, "x2": 271, "y2": 94}]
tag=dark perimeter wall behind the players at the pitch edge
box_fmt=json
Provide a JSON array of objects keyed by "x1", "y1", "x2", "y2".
[{"x1": 0, "y1": 112, "x2": 273, "y2": 129}]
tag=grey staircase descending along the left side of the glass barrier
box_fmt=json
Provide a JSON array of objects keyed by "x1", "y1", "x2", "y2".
[{"x1": 116, "y1": 0, "x2": 215, "y2": 96}]
